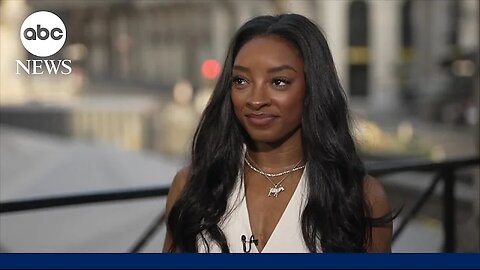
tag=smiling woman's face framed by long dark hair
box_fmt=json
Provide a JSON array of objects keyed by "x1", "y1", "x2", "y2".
[{"x1": 231, "y1": 36, "x2": 305, "y2": 146}]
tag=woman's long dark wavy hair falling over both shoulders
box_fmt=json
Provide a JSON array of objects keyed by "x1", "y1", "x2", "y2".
[{"x1": 167, "y1": 14, "x2": 388, "y2": 252}]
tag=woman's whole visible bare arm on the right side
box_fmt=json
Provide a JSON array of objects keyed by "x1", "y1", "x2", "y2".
[{"x1": 363, "y1": 176, "x2": 392, "y2": 252}]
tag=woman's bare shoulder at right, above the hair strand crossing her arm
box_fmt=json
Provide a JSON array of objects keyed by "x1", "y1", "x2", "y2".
[{"x1": 363, "y1": 175, "x2": 390, "y2": 218}]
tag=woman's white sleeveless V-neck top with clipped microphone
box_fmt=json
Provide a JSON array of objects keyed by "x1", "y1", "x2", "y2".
[{"x1": 197, "y1": 162, "x2": 316, "y2": 253}]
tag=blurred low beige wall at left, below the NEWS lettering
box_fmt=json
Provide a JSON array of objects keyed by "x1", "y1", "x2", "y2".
[{"x1": 0, "y1": 95, "x2": 158, "y2": 151}]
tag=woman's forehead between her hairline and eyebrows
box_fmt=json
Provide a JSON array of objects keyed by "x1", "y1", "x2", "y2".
[{"x1": 235, "y1": 36, "x2": 303, "y2": 68}]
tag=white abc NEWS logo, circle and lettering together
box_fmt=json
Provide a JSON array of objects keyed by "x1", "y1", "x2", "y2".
[{"x1": 16, "y1": 11, "x2": 72, "y2": 75}]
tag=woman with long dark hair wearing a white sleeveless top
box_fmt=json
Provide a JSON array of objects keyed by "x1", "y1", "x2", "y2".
[{"x1": 164, "y1": 14, "x2": 391, "y2": 252}]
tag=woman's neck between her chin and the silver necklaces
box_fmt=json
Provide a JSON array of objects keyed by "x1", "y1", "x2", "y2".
[{"x1": 247, "y1": 129, "x2": 304, "y2": 172}]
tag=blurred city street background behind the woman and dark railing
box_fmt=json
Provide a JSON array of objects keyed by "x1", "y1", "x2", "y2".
[{"x1": 0, "y1": 0, "x2": 480, "y2": 252}]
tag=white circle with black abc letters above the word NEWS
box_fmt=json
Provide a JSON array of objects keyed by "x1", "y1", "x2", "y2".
[{"x1": 20, "y1": 11, "x2": 67, "y2": 57}]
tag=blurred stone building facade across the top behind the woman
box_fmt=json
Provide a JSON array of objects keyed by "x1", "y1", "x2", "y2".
[{"x1": 2, "y1": 0, "x2": 479, "y2": 117}]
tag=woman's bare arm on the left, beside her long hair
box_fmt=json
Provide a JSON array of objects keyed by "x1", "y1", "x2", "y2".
[{"x1": 163, "y1": 167, "x2": 190, "y2": 252}]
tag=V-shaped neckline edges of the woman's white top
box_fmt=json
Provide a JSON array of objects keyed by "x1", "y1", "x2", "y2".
[{"x1": 241, "y1": 167, "x2": 307, "y2": 253}]
